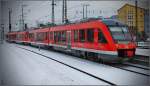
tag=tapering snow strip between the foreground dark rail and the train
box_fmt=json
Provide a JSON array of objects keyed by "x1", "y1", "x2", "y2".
[{"x1": 8, "y1": 44, "x2": 149, "y2": 85}]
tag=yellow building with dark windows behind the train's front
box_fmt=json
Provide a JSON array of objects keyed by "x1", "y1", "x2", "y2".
[{"x1": 118, "y1": 4, "x2": 145, "y2": 37}]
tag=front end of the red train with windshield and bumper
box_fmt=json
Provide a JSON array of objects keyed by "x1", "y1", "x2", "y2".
[{"x1": 102, "y1": 21, "x2": 136, "y2": 62}]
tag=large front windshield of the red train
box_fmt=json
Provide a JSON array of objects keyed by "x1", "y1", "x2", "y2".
[{"x1": 109, "y1": 26, "x2": 132, "y2": 41}]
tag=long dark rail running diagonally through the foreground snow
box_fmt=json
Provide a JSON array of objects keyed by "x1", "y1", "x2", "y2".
[{"x1": 18, "y1": 47, "x2": 117, "y2": 85}]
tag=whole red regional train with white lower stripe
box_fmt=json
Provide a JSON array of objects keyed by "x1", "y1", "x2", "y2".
[{"x1": 6, "y1": 19, "x2": 136, "y2": 62}]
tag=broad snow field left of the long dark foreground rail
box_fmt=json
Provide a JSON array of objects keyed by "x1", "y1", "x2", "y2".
[{"x1": 0, "y1": 44, "x2": 107, "y2": 85}]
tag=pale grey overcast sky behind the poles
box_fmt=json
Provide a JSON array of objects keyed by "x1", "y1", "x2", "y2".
[{"x1": 3, "y1": 0, "x2": 148, "y2": 30}]
